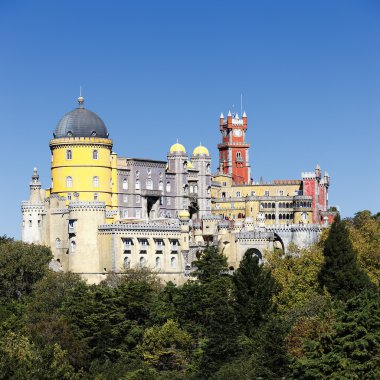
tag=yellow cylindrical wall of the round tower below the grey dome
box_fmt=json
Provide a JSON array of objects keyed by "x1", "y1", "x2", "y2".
[{"x1": 50, "y1": 137, "x2": 112, "y2": 207}]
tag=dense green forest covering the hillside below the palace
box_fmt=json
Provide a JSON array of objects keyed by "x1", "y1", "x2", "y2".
[{"x1": 0, "y1": 211, "x2": 380, "y2": 380}]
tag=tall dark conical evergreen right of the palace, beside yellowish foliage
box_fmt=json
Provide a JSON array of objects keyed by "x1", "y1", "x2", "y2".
[{"x1": 318, "y1": 215, "x2": 371, "y2": 301}]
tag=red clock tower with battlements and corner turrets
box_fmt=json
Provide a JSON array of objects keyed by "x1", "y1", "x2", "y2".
[{"x1": 218, "y1": 112, "x2": 251, "y2": 184}]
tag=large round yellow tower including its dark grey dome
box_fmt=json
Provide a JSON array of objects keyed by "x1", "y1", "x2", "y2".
[{"x1": 50, "y1": 96, "x2": 113, "y2": 208}]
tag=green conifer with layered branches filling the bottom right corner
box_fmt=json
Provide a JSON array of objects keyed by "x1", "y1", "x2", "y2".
[{"x1": 292, "y1": 291, "x2": 380, "y2": 380}]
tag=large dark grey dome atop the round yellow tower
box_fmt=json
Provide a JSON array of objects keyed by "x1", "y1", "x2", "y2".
[{"x1": 53, "y1": 102, "x2": 108, "y2": 138}]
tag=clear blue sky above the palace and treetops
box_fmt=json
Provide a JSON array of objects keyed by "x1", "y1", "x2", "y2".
[{"x1": 0, "y1": 0, "x2": 380, "y2": 238}]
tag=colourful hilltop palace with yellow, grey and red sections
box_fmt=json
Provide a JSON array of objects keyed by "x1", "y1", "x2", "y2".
[{"x1": 22, "y1": 97, "x2": 335, "y2": 283}]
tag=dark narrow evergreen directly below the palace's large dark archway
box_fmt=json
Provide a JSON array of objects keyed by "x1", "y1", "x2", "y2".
[{"x1": 232, "y1": 249, "x2": 279, "y2": 336}]
